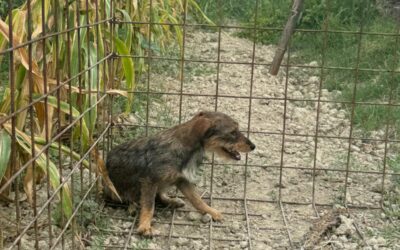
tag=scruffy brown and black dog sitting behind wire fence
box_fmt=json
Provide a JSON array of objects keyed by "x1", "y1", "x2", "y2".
[{"x1": 105, "y1": 112, "x2": 255, "y2": 236}]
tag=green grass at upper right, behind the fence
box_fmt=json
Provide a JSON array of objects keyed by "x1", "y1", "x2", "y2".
[{"x1": 200, "y1": 0, "x2": 400, "y2": 137}]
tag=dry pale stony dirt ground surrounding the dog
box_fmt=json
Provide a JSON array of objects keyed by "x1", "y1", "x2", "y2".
[{"x1": 1, "y1": 28, "x2": 400, "y2": 250}]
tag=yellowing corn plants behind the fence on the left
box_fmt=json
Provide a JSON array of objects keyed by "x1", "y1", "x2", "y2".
[{"x1": 0, "y1": 0, "x2": 211, "y2": 223}]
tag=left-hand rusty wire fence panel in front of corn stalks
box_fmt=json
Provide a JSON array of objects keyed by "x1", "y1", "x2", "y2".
[{"x1": 0, "y1": 0, "x2": 114, "y2": 249}]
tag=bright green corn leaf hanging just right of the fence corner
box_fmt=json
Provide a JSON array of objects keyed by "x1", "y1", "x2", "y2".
[{"x1": 114, "y1": 37, "x2": 135, "y2": 113}]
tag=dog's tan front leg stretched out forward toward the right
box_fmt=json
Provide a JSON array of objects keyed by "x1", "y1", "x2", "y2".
[{"x1": 177, "y1": 180, "x2": 222, "y2": 221}]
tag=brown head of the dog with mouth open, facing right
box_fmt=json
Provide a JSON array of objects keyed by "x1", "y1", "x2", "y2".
[{"x1": 192, "y1": 111, "x2": 256, "y2": 161}]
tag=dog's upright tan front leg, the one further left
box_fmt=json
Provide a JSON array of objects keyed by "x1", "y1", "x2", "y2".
[{"x1": 137, "y1": 181, "x2": 157, "y2": 236}]
